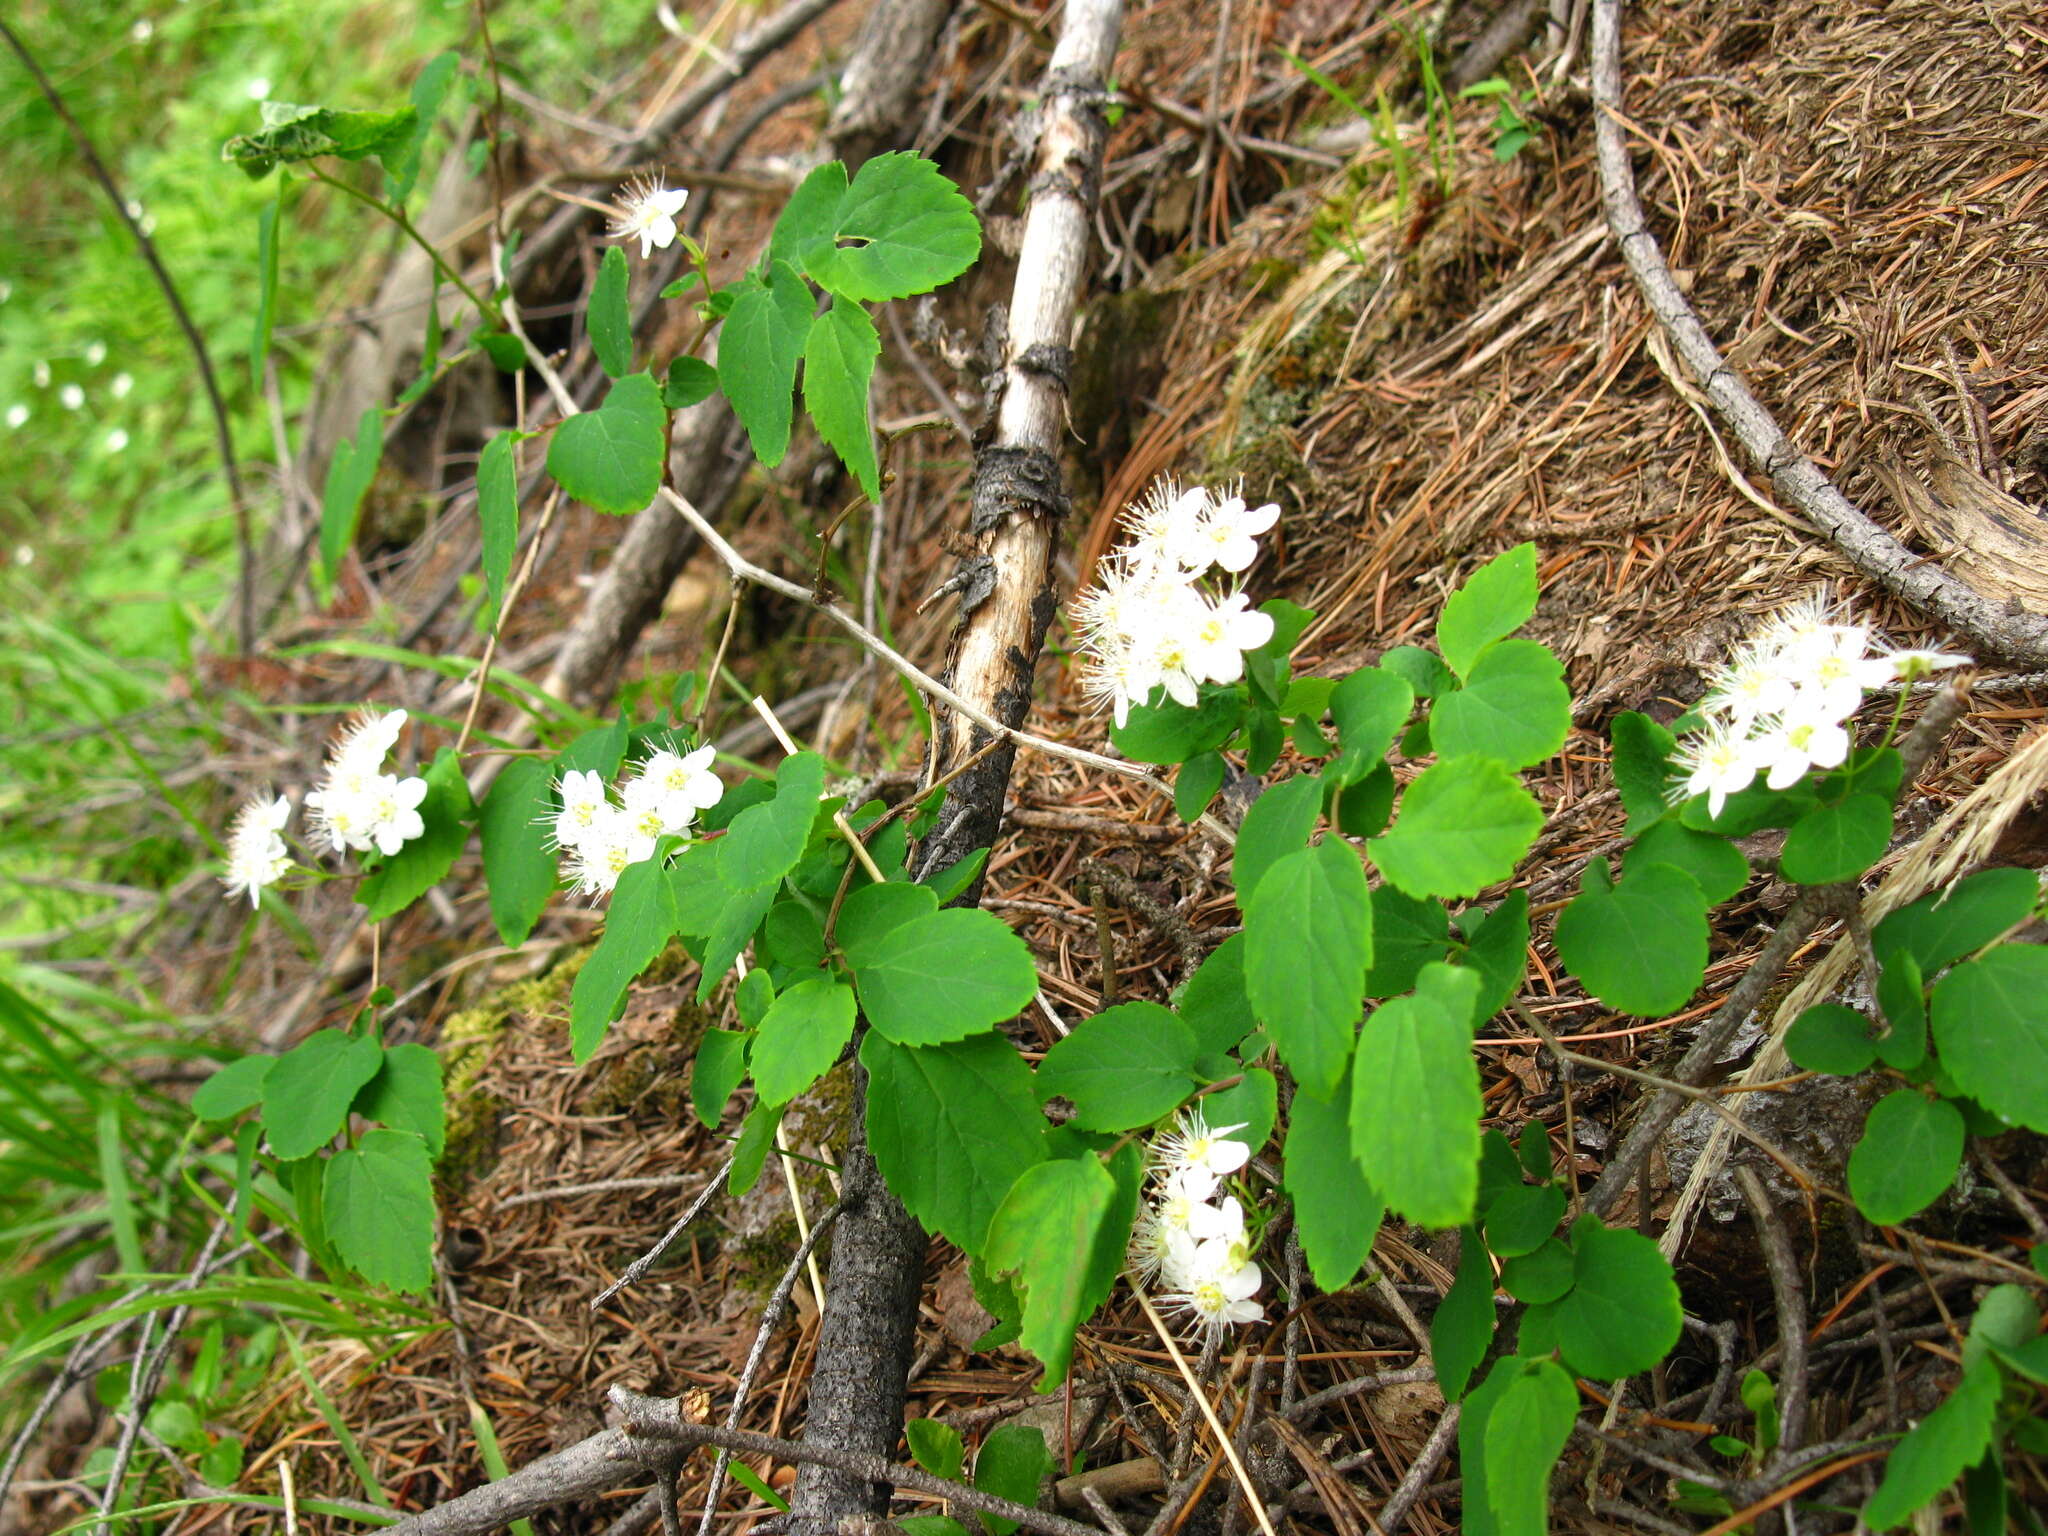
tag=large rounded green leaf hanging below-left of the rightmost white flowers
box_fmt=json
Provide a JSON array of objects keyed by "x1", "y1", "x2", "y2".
[{"x1": 1556, "y1": 864, "x2": 1706, "y2": 1016}]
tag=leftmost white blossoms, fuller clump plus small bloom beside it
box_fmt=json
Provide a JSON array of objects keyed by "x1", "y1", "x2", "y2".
[{"x1": 221, "y1": 709, "x2": 426, "y2": 907}]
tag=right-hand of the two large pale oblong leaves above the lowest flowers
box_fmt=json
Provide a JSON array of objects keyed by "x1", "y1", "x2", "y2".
[{"x1": 1352, "y1": 965, "x2": 1481, "y2": 1227}]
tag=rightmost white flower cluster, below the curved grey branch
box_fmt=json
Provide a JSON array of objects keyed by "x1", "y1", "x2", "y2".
[{"x1": 1671, "y1": 594, "x2": 1970, "y2": 815}]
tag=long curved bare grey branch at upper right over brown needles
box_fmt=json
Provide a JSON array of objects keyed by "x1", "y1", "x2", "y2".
[{"x1": 1593, "y1": 0, "x2": 2048, "y2": 668}]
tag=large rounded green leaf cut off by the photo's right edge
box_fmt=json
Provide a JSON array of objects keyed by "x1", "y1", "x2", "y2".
[{"x1": 1933, "y1": 944, "x2": 2048, "y2": 1130}]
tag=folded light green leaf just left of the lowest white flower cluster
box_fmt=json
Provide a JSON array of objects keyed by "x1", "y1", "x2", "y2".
[{"x1": 978, "y1": 1146, "x2": 1139, "y2": 1391}]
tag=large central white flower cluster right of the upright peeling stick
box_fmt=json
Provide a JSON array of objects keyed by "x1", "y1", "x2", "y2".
[{"x1": 1073, "y1": 479, "x2": 1280, "y2": 725}]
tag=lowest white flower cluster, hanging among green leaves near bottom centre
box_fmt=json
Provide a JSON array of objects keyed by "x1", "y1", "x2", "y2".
[{"x1": 1130, "y1": 1110, "x2": 1266, "y2": 1335}]
